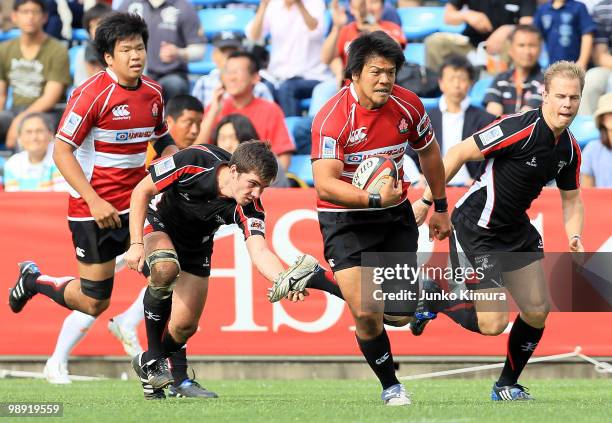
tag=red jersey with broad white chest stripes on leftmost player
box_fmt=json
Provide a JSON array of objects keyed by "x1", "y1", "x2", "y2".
[{"x1": 56, "y1": 69, "x2": 168, "y2": 220}]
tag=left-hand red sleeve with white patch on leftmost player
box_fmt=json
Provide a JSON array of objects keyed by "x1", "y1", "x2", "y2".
[{"x1": 56, "y1": 83, "x2": 111, "y2": 148}]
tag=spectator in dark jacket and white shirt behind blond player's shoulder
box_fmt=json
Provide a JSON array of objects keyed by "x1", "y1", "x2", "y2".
[{"x1": 404, "y1": 55, "x2": 495, "y2": 186}]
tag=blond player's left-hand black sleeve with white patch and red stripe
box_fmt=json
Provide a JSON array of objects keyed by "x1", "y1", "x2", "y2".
[{"x1": 474, "y1": 115, "x2": 536, "y2": 158}]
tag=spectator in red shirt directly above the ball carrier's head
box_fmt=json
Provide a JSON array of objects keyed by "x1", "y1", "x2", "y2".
[{"x1": 321, "y1": 0, "x2": 406, "y2": 79}]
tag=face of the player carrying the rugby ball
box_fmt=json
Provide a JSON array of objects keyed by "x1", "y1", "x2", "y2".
[{"x1": 353, "y1": 56, "x2": 396, "y2": 109}]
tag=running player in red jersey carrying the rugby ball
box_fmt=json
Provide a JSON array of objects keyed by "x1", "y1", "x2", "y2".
[{"x1": 312, "y1": 31, "x2": 451, "y2": 405}]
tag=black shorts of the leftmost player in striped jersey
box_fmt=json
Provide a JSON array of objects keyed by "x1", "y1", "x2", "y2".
[{"x1": 68, "y1": 213, "x2": 130, "y2": 264}]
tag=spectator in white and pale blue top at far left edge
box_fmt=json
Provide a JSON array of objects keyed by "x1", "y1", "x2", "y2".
[{"x1": 4, "y1": 113, "x2": 68, "y2": 191}]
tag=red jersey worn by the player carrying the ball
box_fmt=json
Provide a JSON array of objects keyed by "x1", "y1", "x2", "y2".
[{"x1": 311, "y1": 84, "x2": 434, "y2": 211}]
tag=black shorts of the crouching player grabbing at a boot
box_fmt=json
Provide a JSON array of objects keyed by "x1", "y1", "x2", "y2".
[{"x1": 144, "y1": 208, "x2": 214, "y2": 277}]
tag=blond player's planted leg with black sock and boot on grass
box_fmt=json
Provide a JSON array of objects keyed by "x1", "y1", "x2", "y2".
[{"x1": 492, "y1": 260, "x2": 550, "y2": 400}]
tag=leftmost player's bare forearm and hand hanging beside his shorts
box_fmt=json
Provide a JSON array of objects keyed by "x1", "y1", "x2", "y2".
[{"x1": 53, "y1": 139, "x2": 121, "y2": 229}]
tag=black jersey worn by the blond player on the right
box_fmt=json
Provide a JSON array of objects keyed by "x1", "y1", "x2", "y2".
[{"x1": 456, "y1": 109, "x2": 580, "y2": 229}]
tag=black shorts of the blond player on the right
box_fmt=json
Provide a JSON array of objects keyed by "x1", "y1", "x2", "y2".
[{"x1": 450, "y1": 209, "x2": 544, "y2": 289}]
